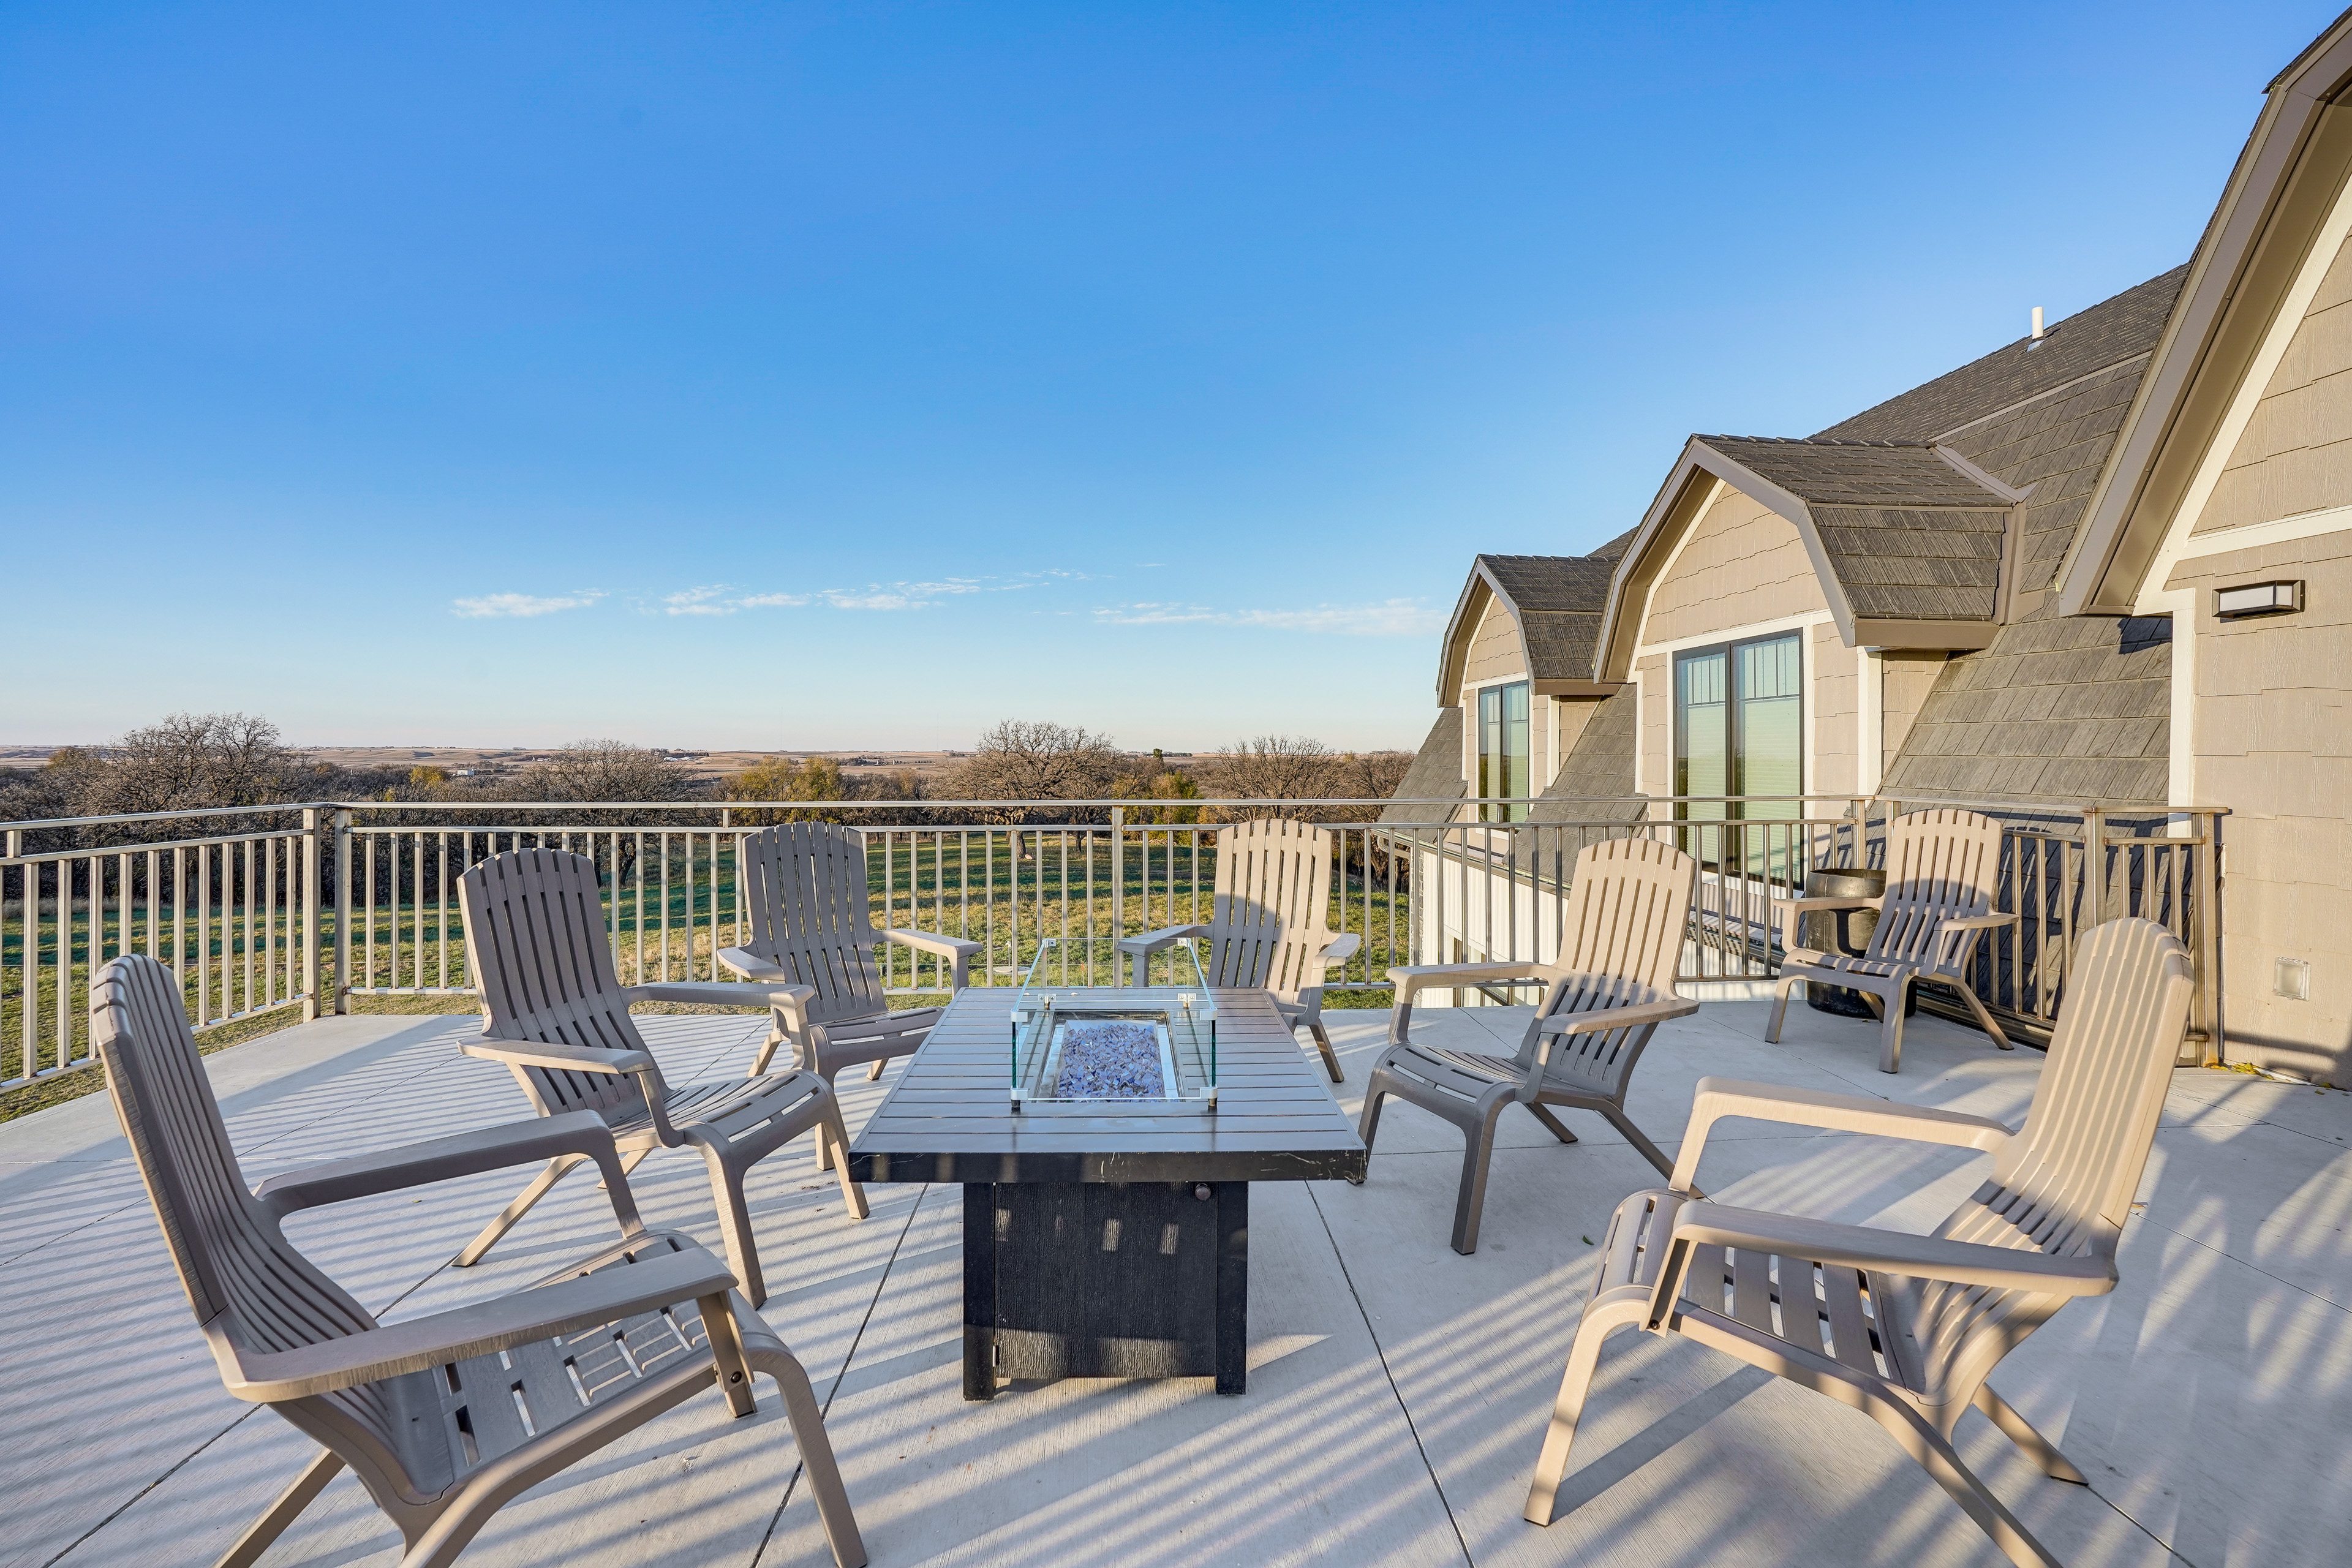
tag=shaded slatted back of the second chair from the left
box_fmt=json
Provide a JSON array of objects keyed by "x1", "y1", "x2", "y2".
[{"x1": 456, "y1": 849, "x2": 647, "y2": 1117}]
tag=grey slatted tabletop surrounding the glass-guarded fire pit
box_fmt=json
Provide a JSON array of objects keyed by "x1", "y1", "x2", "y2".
[{"x1": 849, "y1": 987, "x2": 1366, "y2": 1183}]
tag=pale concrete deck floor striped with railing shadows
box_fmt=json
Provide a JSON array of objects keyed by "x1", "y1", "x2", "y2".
[{"x1": 0, "y1": 1004, "x2": 2352, "y2": 1568}]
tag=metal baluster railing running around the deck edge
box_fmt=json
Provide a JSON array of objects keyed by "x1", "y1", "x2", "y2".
[{"x1": 0, "y1": 794, "x2": 2223, "y2": 1091}]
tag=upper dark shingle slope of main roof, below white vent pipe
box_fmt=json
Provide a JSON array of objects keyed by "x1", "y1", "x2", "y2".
[{"x1": 1814, "y1": 263, "x2": 2190, "y2": 442}]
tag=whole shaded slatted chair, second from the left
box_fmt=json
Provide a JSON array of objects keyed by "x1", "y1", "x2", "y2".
[{"x1": 456, "y1": 849, "x2": 865, "y2": 1307}]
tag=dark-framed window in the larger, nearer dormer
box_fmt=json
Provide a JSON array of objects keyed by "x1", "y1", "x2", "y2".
[{"x1": 1675, "y1": 632, "x2": 1804, "y2": 818}]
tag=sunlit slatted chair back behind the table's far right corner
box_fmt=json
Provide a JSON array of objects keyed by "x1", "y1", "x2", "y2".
[{"x1": 1202, "y1": 816, "x2": 1331, "y2": 995}]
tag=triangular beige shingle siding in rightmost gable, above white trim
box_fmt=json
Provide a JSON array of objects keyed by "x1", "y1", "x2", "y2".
[{"x1": 2195, "y1": 239, "x2": 2352, "y2": 533}]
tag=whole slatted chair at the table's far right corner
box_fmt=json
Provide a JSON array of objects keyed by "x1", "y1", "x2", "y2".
[{"x1": 1120, "y1": 816, "x2": 1364, "y2": 1084}]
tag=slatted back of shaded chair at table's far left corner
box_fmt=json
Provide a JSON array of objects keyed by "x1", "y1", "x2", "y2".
[{"x1": 736, "y1": 823, "x2": 889, "y2": 1023}]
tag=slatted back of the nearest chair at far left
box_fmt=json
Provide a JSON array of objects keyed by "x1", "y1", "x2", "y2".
[{"x1": 89, "y1": 954, "x2": 449, "y2": 1500}]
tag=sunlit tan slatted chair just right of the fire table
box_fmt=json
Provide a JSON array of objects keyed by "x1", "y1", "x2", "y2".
[{"x1": 1362, "y1": 839, "x2": 1698, "y2": 1256}]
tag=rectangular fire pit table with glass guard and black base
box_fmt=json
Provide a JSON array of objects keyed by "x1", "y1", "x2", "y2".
[{"x1": 849, "y1": 938, "x2": 1366, "y2": 1399}]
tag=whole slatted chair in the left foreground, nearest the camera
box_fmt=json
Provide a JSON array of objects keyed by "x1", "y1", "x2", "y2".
[{"x1": 89, "y1": 954, "x2": 865, "y2": 1568}]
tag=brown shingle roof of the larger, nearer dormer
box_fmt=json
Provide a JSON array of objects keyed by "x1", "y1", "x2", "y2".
[{"x1": 1691, "y1": 435, "x2": 2011, "y2": 620}]
